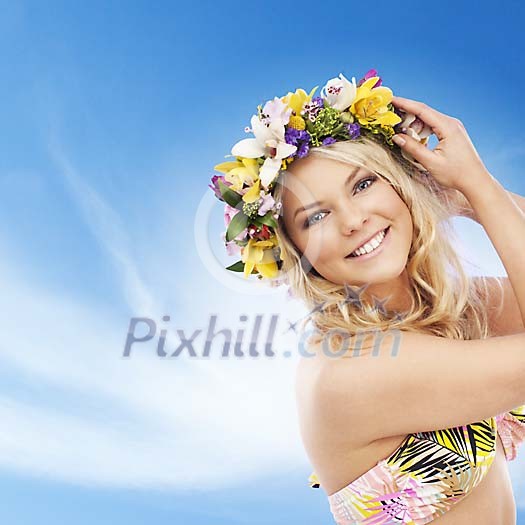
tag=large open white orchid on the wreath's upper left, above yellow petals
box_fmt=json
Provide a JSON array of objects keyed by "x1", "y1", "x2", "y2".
[{"x1": 231, "y1": 97, "x2": 297, "y2": 189}]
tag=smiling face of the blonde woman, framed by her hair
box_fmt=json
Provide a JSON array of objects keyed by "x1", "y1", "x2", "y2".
[{"x1": 282, "y1": 156, "x2": 412, "y2": 285}]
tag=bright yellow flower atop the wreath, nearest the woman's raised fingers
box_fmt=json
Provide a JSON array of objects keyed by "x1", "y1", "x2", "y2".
[{"x1": 350, "y1": 77, "x2": 402, "y2": 126}]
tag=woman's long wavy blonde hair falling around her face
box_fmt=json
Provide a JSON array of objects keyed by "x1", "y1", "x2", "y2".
[{"x1": 274, "y1": 136, "x2": 496, "y2": 346}]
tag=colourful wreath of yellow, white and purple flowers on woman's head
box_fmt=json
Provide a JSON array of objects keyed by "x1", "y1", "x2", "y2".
[{"x1": 209, "y1": 69, "x2": 432, "y2": 280}]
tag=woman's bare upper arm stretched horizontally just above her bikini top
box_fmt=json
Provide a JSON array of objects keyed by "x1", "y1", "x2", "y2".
[{"x1": 311, "y1": 330, "x2": 525, "y2": 444}]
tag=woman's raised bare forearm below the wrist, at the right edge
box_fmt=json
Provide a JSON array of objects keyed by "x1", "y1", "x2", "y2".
[{"x1": 462, "y1": 172, "x2": 525, "y2": 324}]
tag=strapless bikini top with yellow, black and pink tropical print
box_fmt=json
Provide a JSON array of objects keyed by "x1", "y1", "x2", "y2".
[{"x1": 308, "y1": 405, "x2": 525, "y2": 525}]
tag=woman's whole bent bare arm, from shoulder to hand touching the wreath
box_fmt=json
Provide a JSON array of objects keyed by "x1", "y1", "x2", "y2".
[{"x1": 312, "y1": 97, "x2": 525, "y2": 443}]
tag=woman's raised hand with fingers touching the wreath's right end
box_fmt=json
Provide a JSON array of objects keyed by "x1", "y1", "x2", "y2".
[{"x1": 392, "y1": 97, "x2": 492, "y2": 193}]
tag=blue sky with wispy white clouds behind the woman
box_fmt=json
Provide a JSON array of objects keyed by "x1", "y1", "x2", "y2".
[{"x1": 0, "y1": 0, "x2": 525, "y2": 525}]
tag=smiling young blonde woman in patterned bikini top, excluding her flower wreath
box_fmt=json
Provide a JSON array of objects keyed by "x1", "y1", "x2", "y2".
[{"x1": 275, "y1": 97, "x2": 525, "y2": 525}]
